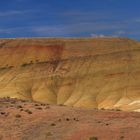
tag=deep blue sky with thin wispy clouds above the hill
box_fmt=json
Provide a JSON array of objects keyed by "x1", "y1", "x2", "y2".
[{"x1": 0, "y1": 0, "x2": 140, "y2": 40}]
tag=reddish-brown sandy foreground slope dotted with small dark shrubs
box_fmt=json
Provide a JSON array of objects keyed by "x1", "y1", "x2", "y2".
[{"x1": 0, "y1": 98, "x2": 140, "y2": 140}]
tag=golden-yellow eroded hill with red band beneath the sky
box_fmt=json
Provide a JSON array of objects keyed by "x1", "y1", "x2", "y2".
[{"x1": 0, "y1": 38, "x2": 140, "y2": 111}]
